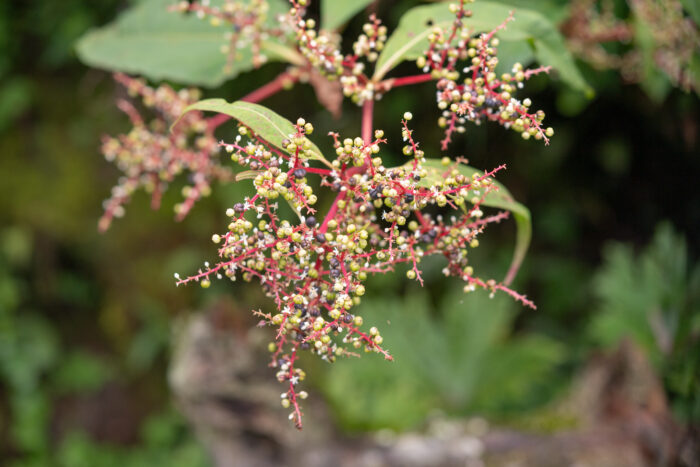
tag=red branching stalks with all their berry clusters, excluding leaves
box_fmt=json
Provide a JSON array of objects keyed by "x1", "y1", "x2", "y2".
[{"x1": 95, "y1": 0, "x2": 551, "y2": 428}]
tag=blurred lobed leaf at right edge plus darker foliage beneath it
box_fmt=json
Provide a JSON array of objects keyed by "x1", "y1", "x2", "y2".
[{"x1": 589, "y1": 223, "x2": 700, "y2": 420}]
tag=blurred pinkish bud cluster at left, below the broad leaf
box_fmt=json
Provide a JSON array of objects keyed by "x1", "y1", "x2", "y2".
[{"x1": 99, "y1": 74, "x2": 232, "y2": 231}]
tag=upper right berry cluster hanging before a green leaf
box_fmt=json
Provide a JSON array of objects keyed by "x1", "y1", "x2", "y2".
[{"x1": 416, "y1": 0, "x2": 554, "y2": 150}]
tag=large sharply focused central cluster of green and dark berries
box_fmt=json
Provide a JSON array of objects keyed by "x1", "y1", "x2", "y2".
[{"x1": 176, "y1": 113, "x2": 534, "y2": 427}]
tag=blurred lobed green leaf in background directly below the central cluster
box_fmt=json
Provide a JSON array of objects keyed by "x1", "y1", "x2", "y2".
[{"x1": 319, "y1": 290, "x2": 565, "y2": 430}]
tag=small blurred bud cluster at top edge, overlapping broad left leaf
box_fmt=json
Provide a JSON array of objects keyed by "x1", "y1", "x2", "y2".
[{"x1": 173, "y1": 0, "x2": 284, "y2": 73}]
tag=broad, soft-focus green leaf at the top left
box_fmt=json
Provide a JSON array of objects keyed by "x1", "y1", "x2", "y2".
[{"x1": 76, "y1": 0, "x2": 297, "y2": 87}]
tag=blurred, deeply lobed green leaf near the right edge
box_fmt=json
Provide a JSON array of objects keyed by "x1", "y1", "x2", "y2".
[{"x1": 590, "y1": 224, "x2": 700, "y2": 365}]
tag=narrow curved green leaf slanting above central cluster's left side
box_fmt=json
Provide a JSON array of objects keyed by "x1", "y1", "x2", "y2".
[{"x1": 173, "y1": 99, "x2": 330, "y2": 165}]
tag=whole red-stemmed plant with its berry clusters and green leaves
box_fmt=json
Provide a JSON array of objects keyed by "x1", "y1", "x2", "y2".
[{"x1": 79, "y1": 0, "x2": 582, "y2": 428}]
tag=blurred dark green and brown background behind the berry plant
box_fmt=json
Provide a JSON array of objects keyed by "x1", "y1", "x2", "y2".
[{"x1": 0, "y1": 0, "x2": 700, "y2": 467}]
